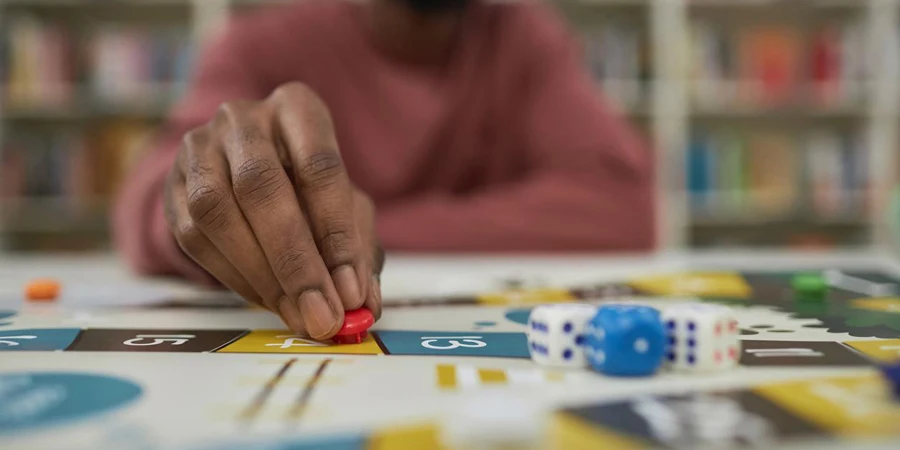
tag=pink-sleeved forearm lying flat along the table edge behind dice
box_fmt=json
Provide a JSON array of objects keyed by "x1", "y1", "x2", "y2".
[{"x1": 377, "y1": 173, "x2": 655, "y2": 252}]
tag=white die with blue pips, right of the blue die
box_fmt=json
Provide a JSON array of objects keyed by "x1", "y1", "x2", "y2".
[{"x1": 662, "y1": 303, "x2": 741, "y2": 372}]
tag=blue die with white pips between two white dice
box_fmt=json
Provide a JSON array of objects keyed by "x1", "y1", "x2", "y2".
[{"x1": 585, "y1": 305, "x2": 666, "y2": 376}]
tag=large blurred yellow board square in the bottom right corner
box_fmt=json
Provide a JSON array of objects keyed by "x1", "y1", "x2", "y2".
[{"x1": 753, "y1": 375, "x2": 900, "y2": 437}]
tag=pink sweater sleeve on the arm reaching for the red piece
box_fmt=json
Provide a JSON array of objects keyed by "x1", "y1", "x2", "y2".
[{"x1": 112, "y1": 25, "x2": 265, "y2": 283}]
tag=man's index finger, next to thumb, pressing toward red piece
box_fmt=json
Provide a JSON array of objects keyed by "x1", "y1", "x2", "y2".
[{"x1": 273, "y1": 85, "x2": 372, "y2": 310}]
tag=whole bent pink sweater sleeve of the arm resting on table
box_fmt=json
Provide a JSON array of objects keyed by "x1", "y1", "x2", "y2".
[{"x1": 377, "y1": 5, "x2": 655, "y2": 252}]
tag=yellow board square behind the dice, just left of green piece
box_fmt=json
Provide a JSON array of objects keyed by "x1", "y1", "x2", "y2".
[{"x1": 628, "y1": 272, "x2": 752, "y2": 299}]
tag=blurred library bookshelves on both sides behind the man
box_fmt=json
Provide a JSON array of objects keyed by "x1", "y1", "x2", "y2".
[{"x1": 0, "y1": 0, "x2": 900, "y2": 253}]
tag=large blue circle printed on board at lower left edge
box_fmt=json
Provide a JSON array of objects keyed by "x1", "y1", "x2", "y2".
[{"x1": 0, "y1": 372, "x2": 142, "y2": 434}]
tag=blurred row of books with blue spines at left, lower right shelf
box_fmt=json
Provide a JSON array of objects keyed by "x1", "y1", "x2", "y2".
[{"x1": 686, "y1": 129, "x2": 871, "y2": 224}]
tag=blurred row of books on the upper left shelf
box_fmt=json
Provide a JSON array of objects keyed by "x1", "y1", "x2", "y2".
[{"x1": 0, "y1": 13, "x2": 194, "y2": 109}]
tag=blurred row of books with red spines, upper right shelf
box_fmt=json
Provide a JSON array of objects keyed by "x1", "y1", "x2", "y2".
[{"x1": 688, "y1": 20, "x2": 867, "y2": 109}]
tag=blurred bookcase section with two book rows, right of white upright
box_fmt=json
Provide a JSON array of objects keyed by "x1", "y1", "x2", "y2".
[{"x1": 684, "y1": 0, "x2": 888, "y2": 247}]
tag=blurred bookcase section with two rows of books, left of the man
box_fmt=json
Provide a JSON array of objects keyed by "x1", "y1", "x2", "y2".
[{"x1": 0, "y1": 0, "x2": 193, "y2": 251}]
